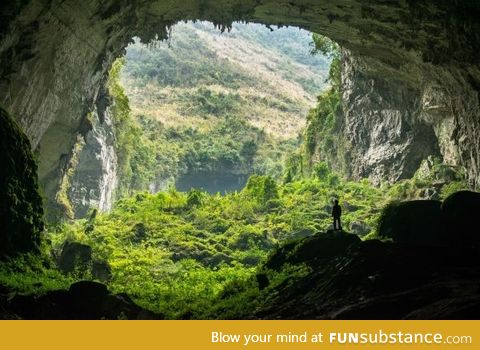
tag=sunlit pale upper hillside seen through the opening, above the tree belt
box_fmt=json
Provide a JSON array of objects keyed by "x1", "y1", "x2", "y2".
[{"x1": 122, "y1": 23, "x2": 329, "y2": 139}]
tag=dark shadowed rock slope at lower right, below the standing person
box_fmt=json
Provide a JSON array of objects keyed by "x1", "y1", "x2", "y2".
[{"x1": 253, "y1": 234, "x2": 480, "y2": 319}]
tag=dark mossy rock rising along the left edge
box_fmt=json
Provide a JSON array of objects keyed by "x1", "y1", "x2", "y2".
[{"x1": 0, "y1": 108, "x2": 43, "y2": 255}]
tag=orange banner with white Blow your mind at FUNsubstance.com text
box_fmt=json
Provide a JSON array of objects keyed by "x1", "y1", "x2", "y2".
[{"x1": 0, "y1": 321, "x2": 480, "y2": 350}]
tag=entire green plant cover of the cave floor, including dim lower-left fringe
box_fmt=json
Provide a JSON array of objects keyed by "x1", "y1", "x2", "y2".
[{"x1": 0, "y1": 160, "x2": 461, "y2": 318}]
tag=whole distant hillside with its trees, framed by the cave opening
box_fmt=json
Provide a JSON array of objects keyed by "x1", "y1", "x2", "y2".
[{"x1": 103, "y1": 22, "x2": 331, "y2": 198}]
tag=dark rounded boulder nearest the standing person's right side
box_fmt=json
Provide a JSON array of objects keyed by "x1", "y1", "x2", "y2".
[{"x1": 378, "y1": 200, "x2": 446, "y2": 245}]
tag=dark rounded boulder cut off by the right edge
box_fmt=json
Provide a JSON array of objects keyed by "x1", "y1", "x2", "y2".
[{"x1": 442, "y1": 191, "x2": 480, "y2": 246}]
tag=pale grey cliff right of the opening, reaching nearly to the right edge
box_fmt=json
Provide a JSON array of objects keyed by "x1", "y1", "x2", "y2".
[{"x1": 341, "y1": 51, "x2": 478, "y2": 186}]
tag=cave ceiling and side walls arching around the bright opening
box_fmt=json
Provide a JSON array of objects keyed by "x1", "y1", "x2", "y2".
[{"x1": 0, "y1": 0, "x2": 480, "y2": 318}]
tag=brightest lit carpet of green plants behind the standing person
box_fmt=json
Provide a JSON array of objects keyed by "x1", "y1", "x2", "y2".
[{"x1": 47, "y1": 171, "x2": 382, "y2": 318}]
